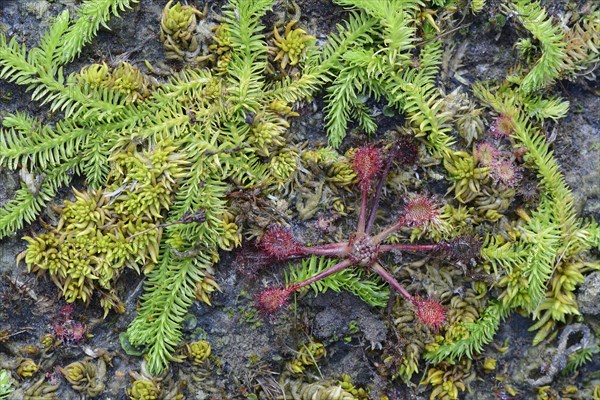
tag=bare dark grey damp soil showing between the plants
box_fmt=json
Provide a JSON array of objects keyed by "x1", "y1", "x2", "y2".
[{"x1": 0, "y1": 0, "x2": 600, "y2": 399}]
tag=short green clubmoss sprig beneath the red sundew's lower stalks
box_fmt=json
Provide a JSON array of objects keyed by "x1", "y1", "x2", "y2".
[{"x1": 286, "y1": 256, "x2": 390, "y2": 307}]
